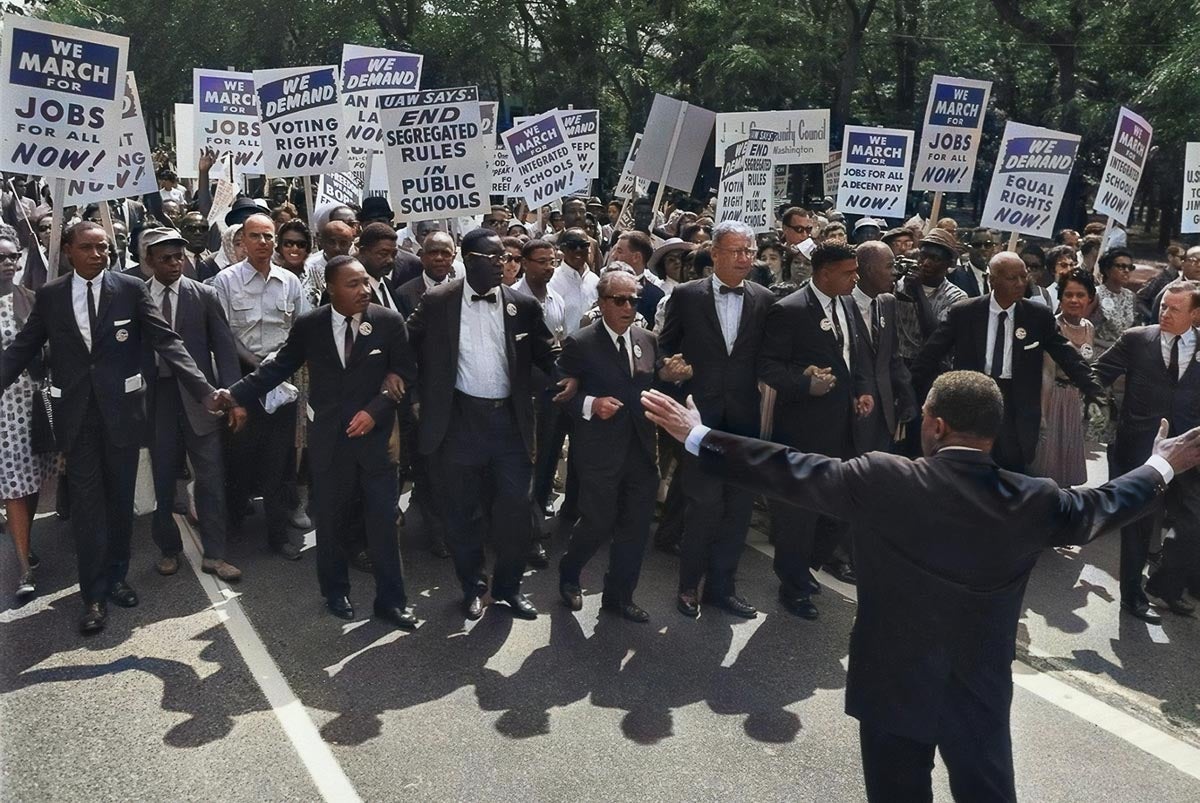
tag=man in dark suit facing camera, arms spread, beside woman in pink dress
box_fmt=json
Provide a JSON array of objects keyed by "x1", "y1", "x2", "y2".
[{"x1": 912, "y1": 251, "x2": 1103, "y2": 472}]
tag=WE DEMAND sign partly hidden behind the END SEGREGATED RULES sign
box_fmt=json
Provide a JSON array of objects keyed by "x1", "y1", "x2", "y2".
[{"x1": 341, "y1": 44, "x2": 425, "y2": 150}]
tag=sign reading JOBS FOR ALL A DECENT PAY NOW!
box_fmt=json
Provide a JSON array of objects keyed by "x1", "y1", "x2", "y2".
[{"x1": 838, "y1": 126, "x2": 912, "y2": 218}]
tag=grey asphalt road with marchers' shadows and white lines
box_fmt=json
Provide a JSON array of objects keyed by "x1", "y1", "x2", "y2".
[{"x1": 0, "y1": 451, "x2": 1200, "y2": 803}]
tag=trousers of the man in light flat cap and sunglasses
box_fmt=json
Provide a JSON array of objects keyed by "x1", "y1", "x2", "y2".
[{"x1": 150, "y1": 377, "x2": 227, "y2": 561}]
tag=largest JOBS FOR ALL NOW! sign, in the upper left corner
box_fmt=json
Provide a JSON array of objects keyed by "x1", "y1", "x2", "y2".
[{"x1": 0, "y1": 14, "x2": 130, "y2": 184}]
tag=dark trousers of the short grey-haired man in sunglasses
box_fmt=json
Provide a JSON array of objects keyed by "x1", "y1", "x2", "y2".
[{"x1": 558, "y1": 444, "x2": 659, "y2": 604}]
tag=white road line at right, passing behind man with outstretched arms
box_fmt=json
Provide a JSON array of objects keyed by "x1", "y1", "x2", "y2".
[{"x1": 749, "y1": 540, "x2": 1200, "y2": 779}]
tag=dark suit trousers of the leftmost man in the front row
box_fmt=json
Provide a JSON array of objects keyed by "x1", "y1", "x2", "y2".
[{"x1": 66, "y1": 395, "x2": 140, "y2": 604}]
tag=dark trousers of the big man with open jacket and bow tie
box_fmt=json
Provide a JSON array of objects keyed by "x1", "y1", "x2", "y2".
[{"x1": 432, "y1": 391, "x2": 533, "y2": 599}]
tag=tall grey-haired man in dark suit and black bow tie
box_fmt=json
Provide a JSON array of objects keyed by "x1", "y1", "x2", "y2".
[{"x1": 659, "y1": 221, "x2": 775, "y2": 618}]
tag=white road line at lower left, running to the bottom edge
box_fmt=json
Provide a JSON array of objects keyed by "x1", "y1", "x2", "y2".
[{"x1": 175, "y1": 516, "x2": 362, "y2": 803}]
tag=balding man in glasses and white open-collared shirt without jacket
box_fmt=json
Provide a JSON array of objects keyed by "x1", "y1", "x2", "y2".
[{"x1": 212, "y1": 214, "x2": 312, "y2": 561}]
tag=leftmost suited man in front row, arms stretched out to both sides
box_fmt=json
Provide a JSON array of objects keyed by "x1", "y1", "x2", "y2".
[{"x1": 0, "y1": 221, "x2": 214, "y2": 634}]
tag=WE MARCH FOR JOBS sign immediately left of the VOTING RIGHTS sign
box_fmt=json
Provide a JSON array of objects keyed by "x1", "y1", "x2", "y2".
[{"x1": 192, "y1": 68, "x2": 263, "y2": 178}]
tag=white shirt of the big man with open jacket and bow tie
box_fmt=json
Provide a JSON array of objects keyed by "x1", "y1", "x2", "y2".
[{"x1": 454, "y1": 282, "x2": 511, "y2": 398}]
